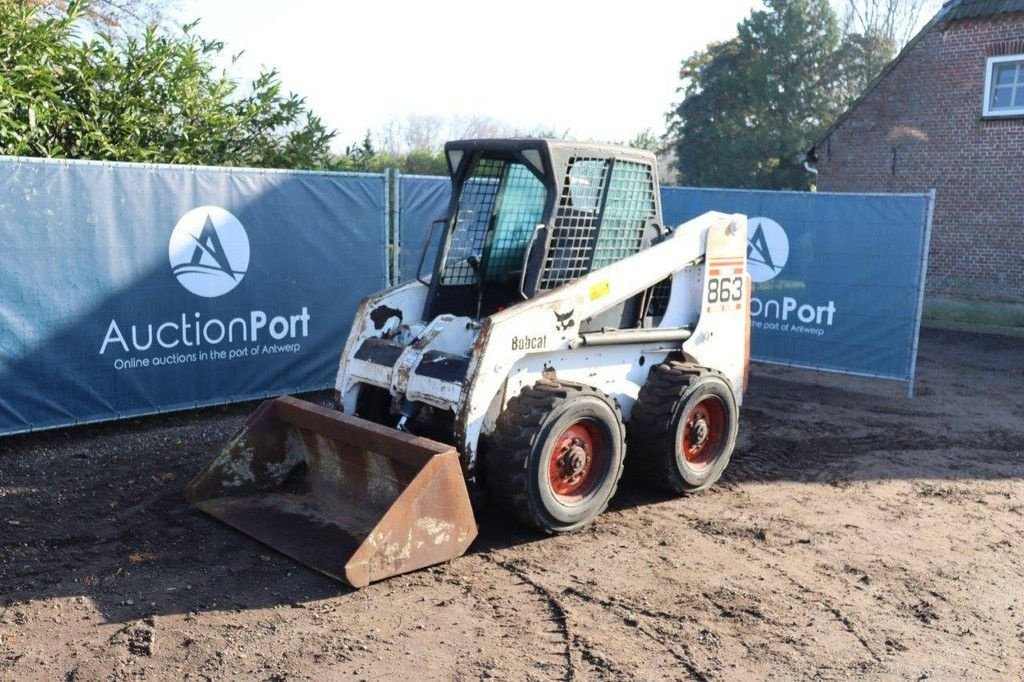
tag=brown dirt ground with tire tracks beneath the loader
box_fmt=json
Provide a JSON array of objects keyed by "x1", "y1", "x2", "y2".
[{"x1": 0, "y1": 330, "x2": 1024, "y2": 680}]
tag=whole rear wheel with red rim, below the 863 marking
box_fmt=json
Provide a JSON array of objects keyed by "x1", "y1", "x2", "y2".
[{"x1": 628, "y1": 360, "x2": 739, "y2": 495}]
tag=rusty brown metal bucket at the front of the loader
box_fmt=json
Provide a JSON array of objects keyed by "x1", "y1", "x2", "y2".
[{"x1": 186, "y1": 397, "x2": 476, "y2": 588}]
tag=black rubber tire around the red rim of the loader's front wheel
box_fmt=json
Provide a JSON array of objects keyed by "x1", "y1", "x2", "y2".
[{"x1": 486, "y1": 380, "x2": 626, "y2": 534}]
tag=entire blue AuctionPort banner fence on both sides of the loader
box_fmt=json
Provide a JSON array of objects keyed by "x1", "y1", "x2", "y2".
[{"x1": 0, "y1": 158, "x2": 932, "y2": 434}]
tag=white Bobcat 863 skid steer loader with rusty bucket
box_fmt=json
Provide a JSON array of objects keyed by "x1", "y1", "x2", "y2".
[{"x1": 187, "y1": 139, "x2": 751, "y2": 587}]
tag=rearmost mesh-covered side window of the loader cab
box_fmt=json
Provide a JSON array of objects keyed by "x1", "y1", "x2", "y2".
[{"x1": 591, "y1": 161, "x2": 655, "y2": 270}]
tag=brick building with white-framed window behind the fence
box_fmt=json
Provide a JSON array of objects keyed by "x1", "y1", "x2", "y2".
[{"x1": 808, "y1": 0, "x2": 1024, "y2": 302}]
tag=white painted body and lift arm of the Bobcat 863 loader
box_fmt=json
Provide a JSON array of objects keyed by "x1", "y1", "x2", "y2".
[{"x1": 335, "y1": 212, "x2": 750, "y2": 481}]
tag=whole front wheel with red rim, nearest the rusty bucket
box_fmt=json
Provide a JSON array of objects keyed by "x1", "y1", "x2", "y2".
[{"x1": 486, "y1": 380, "x2": 625, "y2": 532}]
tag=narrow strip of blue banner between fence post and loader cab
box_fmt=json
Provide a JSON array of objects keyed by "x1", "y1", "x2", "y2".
[{"x1": 395, "y1": 175, "x2": 452, "y2": 282}]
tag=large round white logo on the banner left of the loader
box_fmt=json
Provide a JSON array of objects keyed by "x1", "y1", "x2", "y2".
[{"x1": 167, "y1": 206, "x2": 249, "y2": 298}]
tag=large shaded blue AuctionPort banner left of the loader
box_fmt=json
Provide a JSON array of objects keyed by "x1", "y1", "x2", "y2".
[{"x1": 0, "y1": 158, "x2": 388, "y2": 433}]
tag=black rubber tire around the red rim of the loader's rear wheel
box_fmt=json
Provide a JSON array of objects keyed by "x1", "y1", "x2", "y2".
[{"x1": 627, "y1": 360, "x2": 739, "y2": 495}]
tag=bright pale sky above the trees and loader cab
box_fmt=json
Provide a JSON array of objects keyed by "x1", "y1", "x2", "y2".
[{"x1": 174, "y1": 0, "x2": 937, "y2": 147}]
